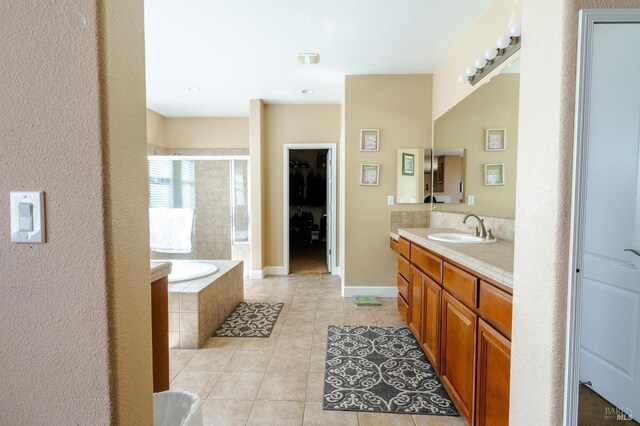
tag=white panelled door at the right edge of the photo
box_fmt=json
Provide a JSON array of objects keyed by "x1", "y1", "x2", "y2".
[{"x1": 580, "y1": 23, "x2": 640, "y2": 417}]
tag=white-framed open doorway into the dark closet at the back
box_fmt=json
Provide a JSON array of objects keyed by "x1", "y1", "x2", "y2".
[{"x1": 283, "y1": 144, "x2": 336, "y2": 274}]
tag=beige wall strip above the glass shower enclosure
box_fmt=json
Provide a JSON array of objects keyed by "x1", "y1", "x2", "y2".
[{"x1": 165, "y1": 117, "x2": 249, "y2": 149}]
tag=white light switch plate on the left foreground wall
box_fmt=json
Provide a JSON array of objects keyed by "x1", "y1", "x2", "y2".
[{"x1": 9, "y1": 191, "x2": 45, "y2": 244}]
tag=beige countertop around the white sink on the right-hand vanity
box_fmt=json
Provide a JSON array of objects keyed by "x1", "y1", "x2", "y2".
[{"x1": 398, "y1": 228, "x2": 513, "y2": 288}]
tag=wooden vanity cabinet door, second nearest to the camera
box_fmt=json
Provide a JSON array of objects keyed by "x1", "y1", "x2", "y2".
[{"x1": 440, "y1": 291, "x2": 477, "y2": 424}]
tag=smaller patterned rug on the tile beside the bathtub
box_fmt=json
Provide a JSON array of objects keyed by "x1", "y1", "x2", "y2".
[{"x1": 213, "y1": 302, "x2": 284, "y2": 337}]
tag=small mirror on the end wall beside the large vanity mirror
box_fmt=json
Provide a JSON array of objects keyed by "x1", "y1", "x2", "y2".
[{"x1": 396, "y1": 148, "x2": 433, "y2": 204}]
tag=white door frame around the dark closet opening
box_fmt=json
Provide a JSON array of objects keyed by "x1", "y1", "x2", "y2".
[{"x1": 282, "y1": 143, "x2": 338, "y2": 275}]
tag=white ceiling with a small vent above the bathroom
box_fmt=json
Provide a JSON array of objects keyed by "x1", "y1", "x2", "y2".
[{"x1": 144, "y1": 0, "x2": 491, "y2": 117}]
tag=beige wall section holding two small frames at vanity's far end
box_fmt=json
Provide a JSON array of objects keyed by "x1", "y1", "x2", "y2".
[{"x1": 343, "y1": 74, "x2": 432, "y2": 286}]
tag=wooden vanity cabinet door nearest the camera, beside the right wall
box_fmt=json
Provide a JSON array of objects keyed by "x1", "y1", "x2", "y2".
[{"x1": 475, "y1": 320, "x2": 511, "y2": 426}]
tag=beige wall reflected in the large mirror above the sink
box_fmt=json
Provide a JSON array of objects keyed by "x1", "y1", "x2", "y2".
[{"x1": 433, "y1": 74, "x2": 520, "y2": 218}]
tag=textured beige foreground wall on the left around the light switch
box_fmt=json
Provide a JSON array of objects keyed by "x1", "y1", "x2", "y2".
[{"x1": 0, "y1": 0, "x2": 152, "y2": 424}]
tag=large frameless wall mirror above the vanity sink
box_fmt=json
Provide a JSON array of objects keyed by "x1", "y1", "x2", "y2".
[{"x1": 433, "y1": 55, "x2": 520, "y2": 218}]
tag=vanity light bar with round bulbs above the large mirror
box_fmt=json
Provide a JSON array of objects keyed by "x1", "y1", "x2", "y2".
[{"x1": 458, "y1": 22, "x2": 522, "y2": 86}]
